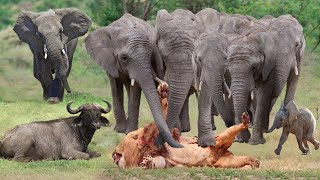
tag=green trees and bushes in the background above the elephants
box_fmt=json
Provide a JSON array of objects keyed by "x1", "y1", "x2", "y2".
[{"x1": 0, "y1": 0, "x2": 320, "y2": 51}]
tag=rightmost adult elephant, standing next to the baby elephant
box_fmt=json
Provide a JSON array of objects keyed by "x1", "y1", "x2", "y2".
[{"x1": 227, "y1": 15, "x2": 305, "y2": 145}]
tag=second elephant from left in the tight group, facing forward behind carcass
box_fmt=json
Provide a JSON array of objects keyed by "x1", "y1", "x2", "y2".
[{"x1": 155, "y1": 9, "x2": 205, "y2": 135}]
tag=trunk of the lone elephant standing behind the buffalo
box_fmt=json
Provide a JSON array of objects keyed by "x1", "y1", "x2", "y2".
[{"x1": 46, "y1": 36, "x2": 71, "y2": 93}]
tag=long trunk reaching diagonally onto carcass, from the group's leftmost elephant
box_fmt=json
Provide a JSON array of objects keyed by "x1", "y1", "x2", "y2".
[{"x1": 136, "y1": 69, "x2": 182, "y2": 148}]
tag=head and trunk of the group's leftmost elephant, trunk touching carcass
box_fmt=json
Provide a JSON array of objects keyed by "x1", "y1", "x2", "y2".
[{"x1": 85, "y1": 14, "x2": 181, "y2": 147}]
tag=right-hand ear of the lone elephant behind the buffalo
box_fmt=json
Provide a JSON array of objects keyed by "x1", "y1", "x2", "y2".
[{"x1": 55, "y1": 8, "x2": 92, "y2": 43}]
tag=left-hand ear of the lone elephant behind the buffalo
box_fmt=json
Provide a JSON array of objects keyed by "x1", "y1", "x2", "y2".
[{"x1": 13, "y1": 11, "x2": 43, "y2": 52}]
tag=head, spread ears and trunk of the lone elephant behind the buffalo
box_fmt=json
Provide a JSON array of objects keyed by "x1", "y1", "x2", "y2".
[{"x1": 13, "y1": 8, "x2": 91, "y2": 92}]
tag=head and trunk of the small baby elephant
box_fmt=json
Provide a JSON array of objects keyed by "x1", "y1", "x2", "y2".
[{"x1": 267, "y1": 101, "x2": 300, "y2": 133}]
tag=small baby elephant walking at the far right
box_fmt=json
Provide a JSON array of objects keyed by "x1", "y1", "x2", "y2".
[{"x1": 267, "y1": 101, "x2": 319, "y2": 155}]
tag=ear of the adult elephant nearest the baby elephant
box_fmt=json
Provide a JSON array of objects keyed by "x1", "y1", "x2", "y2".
[{"x1": 258, "y1": 32, "x2": 276, "y2": 81}]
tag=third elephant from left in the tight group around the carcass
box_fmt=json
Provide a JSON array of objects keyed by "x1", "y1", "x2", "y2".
[{"x1": 194, "y1": 33, "x2": 235, "y2": 146}]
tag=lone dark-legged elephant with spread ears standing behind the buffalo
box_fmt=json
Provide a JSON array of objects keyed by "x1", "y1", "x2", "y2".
[{"x1": 13, "y1": 8, "x2": 91, "y2": 103}]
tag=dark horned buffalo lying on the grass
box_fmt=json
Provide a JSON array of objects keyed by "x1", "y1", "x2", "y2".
[{"x1": 0, "y1": 101, "x2": 111, "y2": 162}]
